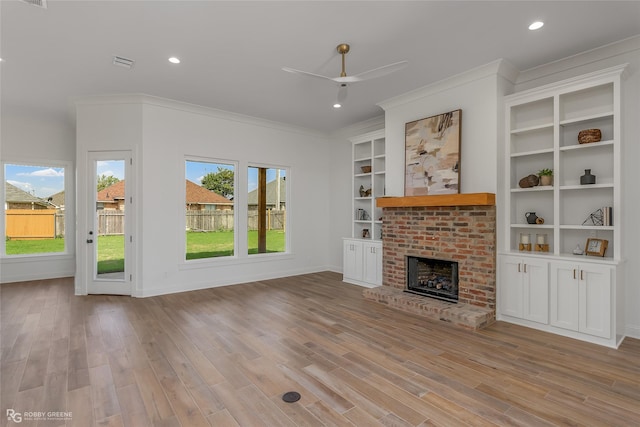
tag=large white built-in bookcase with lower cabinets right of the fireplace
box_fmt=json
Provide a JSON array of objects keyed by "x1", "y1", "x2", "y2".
[{"x1": 497, "y1": 65, "x2": 626, "y2": 347}]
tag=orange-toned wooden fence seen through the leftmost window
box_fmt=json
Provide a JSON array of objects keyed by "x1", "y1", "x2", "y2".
[{"x1": 5, "y1": 209, "x2": 64, "y2": 240}]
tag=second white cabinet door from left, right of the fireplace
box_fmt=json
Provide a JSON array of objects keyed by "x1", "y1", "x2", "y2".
[{"x1": 521, "y1": 259, "x2": 549, "y2": 324}]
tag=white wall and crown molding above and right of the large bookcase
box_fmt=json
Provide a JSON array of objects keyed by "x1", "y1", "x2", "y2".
[{"x1": 516, "y1": 36, "x2": 640, "y2": 338}]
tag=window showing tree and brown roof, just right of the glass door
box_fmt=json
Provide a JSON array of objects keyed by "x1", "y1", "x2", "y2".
[{"x1": 185, "y1": 160, "x2": 236, "y2": 260}]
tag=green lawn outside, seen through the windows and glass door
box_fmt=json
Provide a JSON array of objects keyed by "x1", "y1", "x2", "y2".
[{"x1": 6, "y1": 230, "x2": 285, "y2": 274}]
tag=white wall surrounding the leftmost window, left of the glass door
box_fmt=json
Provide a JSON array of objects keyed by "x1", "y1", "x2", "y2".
[{"x1": 0, "y1": 112, "x2": 75, "y2": 283}]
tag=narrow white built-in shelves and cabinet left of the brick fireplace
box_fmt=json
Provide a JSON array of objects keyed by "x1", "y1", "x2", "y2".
[{"x1": 343, "y1": 130, "x2": 385, "y2": 286}]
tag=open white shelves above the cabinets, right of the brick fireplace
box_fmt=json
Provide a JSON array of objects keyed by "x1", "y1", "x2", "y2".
[{"x1": 504, "y1": 67, "x2": 622, "y2": 260}]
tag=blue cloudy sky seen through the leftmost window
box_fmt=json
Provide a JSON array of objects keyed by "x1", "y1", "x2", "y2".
[{"x1": 4, "y1": 164, "x2": 64, "y2": 198}]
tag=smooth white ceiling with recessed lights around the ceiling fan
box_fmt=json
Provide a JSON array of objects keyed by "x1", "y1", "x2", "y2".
[{"x1": 0, "y1": 0, "x2": 640, "y2": 132}]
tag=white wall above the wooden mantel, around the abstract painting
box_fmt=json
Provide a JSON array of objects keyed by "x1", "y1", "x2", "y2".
[{"x1": 379, "y1": 61, "x2": 513, "y2": 196}]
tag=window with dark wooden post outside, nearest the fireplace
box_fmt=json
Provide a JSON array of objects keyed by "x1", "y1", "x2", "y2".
[{"x1": 247, "y1": 166, "x2": 287, "y2": 255}]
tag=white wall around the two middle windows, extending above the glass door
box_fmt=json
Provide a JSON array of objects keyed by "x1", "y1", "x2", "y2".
[{"x1": 78, "y1": 96, "x2": 332, "y2": 296}]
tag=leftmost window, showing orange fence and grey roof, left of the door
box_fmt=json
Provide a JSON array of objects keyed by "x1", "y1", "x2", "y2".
[{"x1": 4, "y1": 163, "x2": 66, "y2": 255}]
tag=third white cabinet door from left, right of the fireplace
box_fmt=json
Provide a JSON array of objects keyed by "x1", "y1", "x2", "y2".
[{"x1": 549, "y1": 262, "x2": 580, "y2": 331}]
